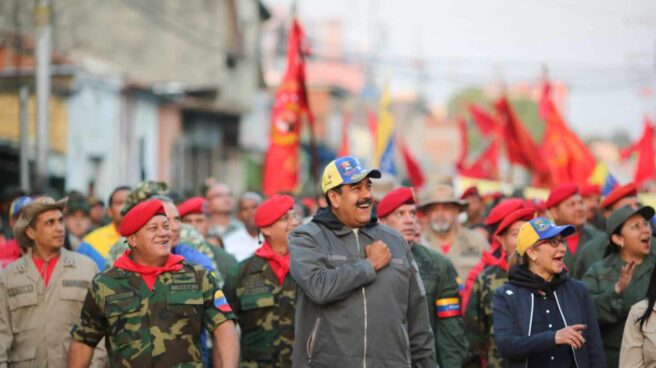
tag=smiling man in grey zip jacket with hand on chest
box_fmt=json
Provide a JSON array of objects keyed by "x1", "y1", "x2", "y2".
[{"x1": 289, "y1": 156, "x2": 437, "y2": 368}]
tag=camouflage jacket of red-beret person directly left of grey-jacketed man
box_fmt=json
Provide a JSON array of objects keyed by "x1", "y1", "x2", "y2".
[{"x1": 225, "y1": 255, "x2": 296, "y2": 368}]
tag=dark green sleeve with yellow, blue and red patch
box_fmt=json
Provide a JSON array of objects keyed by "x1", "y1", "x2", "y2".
[{"x1": 433, "y1": 259, "x2": 467, "y2": 367}]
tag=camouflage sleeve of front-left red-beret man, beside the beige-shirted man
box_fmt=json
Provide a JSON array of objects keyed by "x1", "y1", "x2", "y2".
[{"x1": 71, "y1": 275, "x2": 107, "y2": 347}]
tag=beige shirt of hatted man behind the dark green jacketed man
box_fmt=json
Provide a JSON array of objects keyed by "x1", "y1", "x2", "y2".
[{"x1": 424, "y1": 226, "x2": 490, "y2": 281}]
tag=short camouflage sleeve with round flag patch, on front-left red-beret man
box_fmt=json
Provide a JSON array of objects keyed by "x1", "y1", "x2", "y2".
[{"x1": 201, "y1": 269, "x2": 240, "y2": 332}]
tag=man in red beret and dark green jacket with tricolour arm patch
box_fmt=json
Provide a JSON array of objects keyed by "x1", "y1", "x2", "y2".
[{"x1": 378, "y1": 188, "x2": 467, "y2": 367}]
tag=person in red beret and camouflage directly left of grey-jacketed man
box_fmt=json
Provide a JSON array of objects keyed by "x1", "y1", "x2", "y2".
[{"x1": 226, "y1": 195, "x2": 299, "y2": 368}]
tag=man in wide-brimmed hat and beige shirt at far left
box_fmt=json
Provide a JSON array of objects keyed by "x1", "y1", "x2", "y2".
[{"x1": 0, "y1": 197, "x2": 106, "y2": 367}]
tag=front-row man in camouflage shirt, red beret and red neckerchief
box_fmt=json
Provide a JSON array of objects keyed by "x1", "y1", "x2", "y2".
[{"x1": 68, "y1": 199, "x2": 239, "y2": 368}]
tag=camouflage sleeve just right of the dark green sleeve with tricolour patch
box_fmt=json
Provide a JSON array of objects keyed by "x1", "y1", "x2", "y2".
[{"x1": 464, "y1": 274, "x2": 488, "y2": 366}]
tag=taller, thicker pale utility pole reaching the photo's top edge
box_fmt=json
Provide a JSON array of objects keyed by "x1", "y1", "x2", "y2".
[{"x1": 34, "y1": 0, "x2": 52, "y2": 191}]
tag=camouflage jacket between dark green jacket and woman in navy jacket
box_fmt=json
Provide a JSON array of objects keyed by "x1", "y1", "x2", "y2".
[{"x1": 464, "y1": 266, "x2": 508, "y2": 368}]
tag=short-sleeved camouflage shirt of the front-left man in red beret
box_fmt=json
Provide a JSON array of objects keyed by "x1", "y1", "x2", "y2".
[{"x1": 71, "y1": 261, "x2": 234, "y2": 367}]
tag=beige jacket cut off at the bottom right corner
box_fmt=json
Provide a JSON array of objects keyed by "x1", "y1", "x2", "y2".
[{"x1": 619, "y1": 299, "x2": 656, "y2": 368}]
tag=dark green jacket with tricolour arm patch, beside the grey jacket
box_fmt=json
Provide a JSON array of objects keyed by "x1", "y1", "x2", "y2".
[{"x1": 412, "y1": 244, "x2": 467, "y2": 367}]
